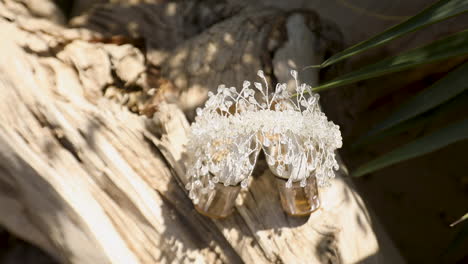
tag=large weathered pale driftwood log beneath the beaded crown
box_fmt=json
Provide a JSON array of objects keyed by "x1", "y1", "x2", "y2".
[{"x1": 0, "y1": 0, "x2": 402, "y2": 263}]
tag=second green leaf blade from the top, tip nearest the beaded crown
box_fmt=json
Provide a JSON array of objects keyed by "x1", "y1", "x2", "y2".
[{"x1": 313, "y1": 30, "x2": 468, "y2": 92}]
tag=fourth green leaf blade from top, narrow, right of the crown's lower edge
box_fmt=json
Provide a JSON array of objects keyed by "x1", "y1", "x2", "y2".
[{"x1": 352, "y1": 92, "x2": 468, "y2": 148}]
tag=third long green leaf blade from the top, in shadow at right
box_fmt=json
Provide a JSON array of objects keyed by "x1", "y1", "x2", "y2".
[{"x1": 366, "y1": 62, "x2": 468, "y2": 137}]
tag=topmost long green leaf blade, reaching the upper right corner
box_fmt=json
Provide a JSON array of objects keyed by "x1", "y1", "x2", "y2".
[{"x1": 321, "y1": 0, "x2": 468, "y2": 67}]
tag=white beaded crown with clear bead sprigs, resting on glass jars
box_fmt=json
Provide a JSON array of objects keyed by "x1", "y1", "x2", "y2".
[{"x1": 186, "y1": 71, "x2": 342, "y2": 204}]
